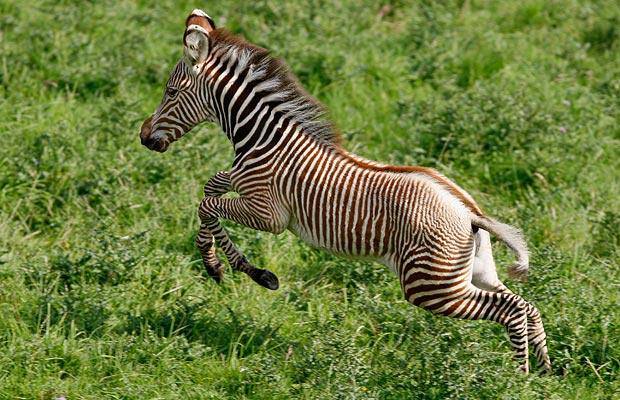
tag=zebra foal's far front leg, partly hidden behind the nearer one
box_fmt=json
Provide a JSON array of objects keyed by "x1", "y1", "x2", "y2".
[{"x1": 196, "y1": 171, "x2": 232, "y2": 283}]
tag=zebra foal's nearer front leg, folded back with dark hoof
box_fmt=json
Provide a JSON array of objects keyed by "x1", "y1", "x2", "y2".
[{"x1": 198, "y1": 196, "x2": 283, "y2": 290}]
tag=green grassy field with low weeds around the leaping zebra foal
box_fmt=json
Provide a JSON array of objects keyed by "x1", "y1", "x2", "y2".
[{"x1": 0, "y1": 0, "x2": 620, "y2": 400}]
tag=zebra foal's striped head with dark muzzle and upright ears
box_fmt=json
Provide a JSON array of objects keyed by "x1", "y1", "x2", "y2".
[{"x1": 140, "y1": 10, "x2": 215, "y2": 153}]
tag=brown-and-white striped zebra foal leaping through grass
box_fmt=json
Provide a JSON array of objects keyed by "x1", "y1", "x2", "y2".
[{"x1": 140, "y1": 10, "x2": 551, "y2": 373}]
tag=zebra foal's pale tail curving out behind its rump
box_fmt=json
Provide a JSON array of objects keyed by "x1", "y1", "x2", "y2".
[{"x1": 471, "y1": 215, "x2": 530, "y2": 281}]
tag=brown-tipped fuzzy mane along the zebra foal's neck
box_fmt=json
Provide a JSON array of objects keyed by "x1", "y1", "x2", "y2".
[{"x1": 209, "y1": 28, "x2": 340, "y2": 147}]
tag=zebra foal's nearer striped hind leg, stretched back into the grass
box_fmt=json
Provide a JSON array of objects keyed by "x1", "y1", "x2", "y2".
[{"x1": 405, "y1": 281, "x2": 529, "y2": 373}]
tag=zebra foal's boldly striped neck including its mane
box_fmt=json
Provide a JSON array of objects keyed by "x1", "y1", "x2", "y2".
[{"x1": 202, "y1": 36, "x2": 336, "y2": 164}]
